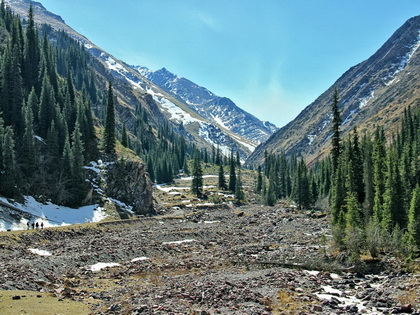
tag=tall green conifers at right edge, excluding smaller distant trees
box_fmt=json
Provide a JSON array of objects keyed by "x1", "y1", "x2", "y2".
[{"x1": 330, "y1": 100, "x2": 420, "y2": 257}]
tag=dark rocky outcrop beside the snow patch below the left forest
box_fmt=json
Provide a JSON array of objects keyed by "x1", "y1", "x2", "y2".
[{"x1": 105, "y1": 159, "x2": 154, "y2": 215}]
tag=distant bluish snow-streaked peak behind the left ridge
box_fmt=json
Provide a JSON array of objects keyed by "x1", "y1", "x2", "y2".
[{"x1": 132, "y1": 66, "x2": 278, "y2": 144}]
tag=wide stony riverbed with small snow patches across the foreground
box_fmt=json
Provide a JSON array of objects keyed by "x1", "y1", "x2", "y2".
[{"x1": 0, "y1": 205, "x2": 420, "y2": 314}]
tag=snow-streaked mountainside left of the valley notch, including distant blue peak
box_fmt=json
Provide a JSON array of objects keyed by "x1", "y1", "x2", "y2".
[{"x1": 6, "y1": 0, "x2": 277, "y2": 160}]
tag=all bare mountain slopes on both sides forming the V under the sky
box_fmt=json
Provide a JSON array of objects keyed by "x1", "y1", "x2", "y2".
[{"x1": 6, "y1": 0, "x2": 420, "y2": 165}]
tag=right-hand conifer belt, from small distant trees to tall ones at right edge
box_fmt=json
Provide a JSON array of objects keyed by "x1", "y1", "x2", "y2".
[{"x1": 256, "y1": 94, "x2": 420, "y2": 257}]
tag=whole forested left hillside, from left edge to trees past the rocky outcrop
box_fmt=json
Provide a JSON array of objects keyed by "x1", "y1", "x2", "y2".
[{"x1": 0, "y1": 1, "x2": 193, "y2": 207}]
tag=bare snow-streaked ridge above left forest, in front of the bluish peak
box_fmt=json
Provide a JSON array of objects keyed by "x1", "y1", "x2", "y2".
[{"x1": 5, "y1": 0, "x2": 257, "y2": 159}]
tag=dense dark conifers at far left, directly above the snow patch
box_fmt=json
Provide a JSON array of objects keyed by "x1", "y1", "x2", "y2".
[{"x1": 0, "y1": 1, "x2": 98, "y2": 206}]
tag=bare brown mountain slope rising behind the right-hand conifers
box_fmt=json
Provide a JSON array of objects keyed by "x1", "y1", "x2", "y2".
[{"x1": 247, "y1": 16, "x2": 420, "y2": 168}]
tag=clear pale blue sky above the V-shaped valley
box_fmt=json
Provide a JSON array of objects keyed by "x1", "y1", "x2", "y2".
[{"x1": 40, "y1": 0, "x2": 420, "y2": 127}]
